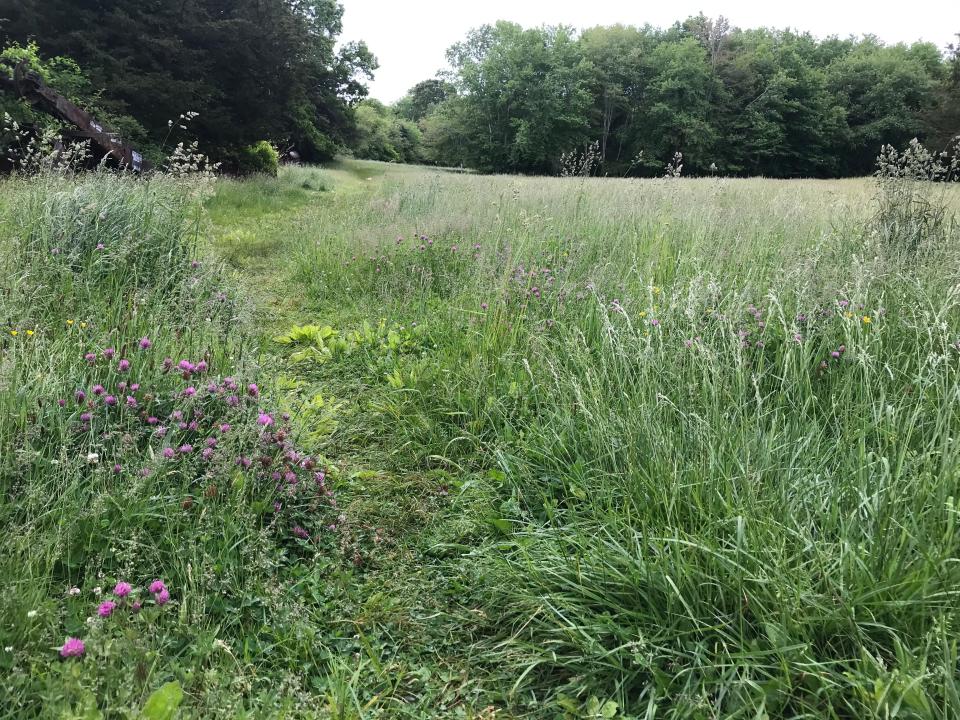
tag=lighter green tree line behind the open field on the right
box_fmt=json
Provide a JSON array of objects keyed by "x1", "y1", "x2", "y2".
[{"x1": 355, "y1": 15, "x2": 960, "y2": 177}]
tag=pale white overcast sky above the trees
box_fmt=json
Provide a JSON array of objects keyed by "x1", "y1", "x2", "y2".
[{"x1": 340, "y1": 0, "x2": 960, "y2": 102}]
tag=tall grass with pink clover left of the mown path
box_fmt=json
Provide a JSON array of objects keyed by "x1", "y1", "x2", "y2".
[{"x1": 0, "y1": 173, "x2": 341, "y2": 718}]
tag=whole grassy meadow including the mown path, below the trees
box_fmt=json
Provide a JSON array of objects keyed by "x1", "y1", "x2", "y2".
[{"x1": 0, "y1": 161, "x2": 960, "y2": 720}]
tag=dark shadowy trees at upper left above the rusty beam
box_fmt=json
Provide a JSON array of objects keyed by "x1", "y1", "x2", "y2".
[{"x1": 0, "y1": 0, "x2": 376, "y2": 164}]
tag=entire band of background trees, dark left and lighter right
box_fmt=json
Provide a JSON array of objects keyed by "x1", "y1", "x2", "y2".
[{"x1": 0, "y1": 0, "x2": 960, "y2": 177}]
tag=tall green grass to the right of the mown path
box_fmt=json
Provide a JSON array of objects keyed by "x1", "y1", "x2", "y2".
[{"x1": 221, "y1": 160, "x2": 960, "y2": 718}]
